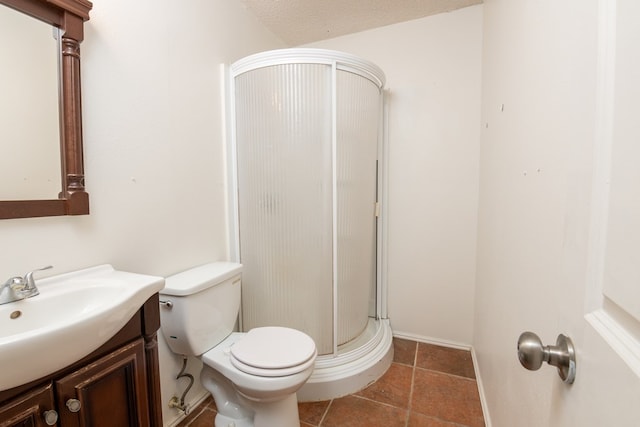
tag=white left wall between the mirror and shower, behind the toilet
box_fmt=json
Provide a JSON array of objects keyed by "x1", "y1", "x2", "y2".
[{"x1": 0, "y1": 0, "x2": 283, "y2": 422}]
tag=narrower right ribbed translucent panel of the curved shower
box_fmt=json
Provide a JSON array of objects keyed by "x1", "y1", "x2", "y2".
[{"x1": 336, "y1": 70, "x2": 381, "y2": 345}]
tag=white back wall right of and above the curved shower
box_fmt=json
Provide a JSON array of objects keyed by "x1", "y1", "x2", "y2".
[{"x1": 307, "y1": 6, "x2": 482, "y2": 345}]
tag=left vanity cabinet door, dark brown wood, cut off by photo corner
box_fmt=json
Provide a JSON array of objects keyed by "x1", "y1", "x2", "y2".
[{"x1": 0, "y1": 384, "x2": 57, "y2": 427}]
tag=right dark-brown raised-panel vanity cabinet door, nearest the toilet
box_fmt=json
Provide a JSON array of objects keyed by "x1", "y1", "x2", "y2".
[{"x1": 55, "y1": 339, "x2": 149, "y2": 427}]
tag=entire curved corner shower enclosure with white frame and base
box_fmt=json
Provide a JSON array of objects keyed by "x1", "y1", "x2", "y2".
[{"x1": 229, "y1": 49, "x2": 392, "y2": 400}]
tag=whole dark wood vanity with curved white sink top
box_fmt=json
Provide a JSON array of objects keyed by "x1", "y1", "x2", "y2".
[{"x1": 0, "y1": 265, "x2": 164, "y2": 427}]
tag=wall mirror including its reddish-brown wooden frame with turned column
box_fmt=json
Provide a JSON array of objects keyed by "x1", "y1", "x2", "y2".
[{"x1": 0, "y1": 0, "x2": 92, "y2": 219}]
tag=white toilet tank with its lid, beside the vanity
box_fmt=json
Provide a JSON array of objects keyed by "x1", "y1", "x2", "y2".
[{"x1": 160, "y1": 262, "x2": 242, "y2": 356}]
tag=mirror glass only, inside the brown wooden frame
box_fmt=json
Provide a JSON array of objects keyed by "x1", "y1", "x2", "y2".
[{"x1": 0, "y1": 6, "x2": 60, "y2": 200}]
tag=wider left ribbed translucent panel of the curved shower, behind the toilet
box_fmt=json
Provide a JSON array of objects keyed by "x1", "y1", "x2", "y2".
[{"x1": 235, "y1": 64, "x2": 333, "y2": 354}]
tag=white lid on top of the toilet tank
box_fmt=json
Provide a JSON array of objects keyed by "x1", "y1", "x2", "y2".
[{"x1": 160, "y1": 262, "x2": 242, "y2": 296}]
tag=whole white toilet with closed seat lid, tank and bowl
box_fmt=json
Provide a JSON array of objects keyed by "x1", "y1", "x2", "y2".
[{"x1": 160, "y1": 262, "x2": 317, "y2": 427}]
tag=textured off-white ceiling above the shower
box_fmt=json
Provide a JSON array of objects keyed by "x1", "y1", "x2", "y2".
[{"x1": 240, "y1": 0, "x2": 482, "y2": 46}]
